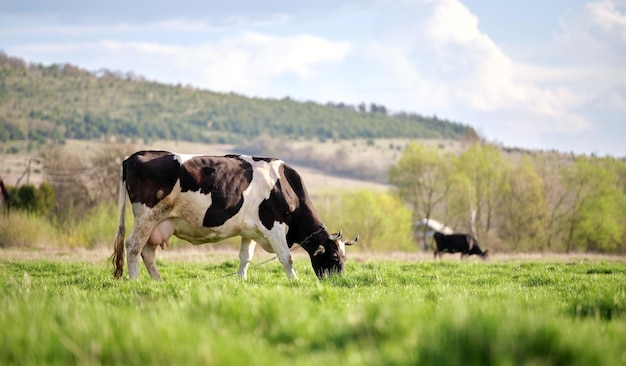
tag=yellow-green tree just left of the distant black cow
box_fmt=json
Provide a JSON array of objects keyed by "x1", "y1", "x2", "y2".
[{"x1": 389, "y1": 143, "x2": 452, "y2": 249}]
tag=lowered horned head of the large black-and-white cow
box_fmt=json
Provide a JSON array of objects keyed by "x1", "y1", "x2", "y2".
[{"x1": 311, "y1": 230, "x2": 359, "y2": 279}]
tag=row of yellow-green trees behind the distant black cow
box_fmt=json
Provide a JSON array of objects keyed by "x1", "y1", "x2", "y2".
[{"x1": 389, "y1": 143, "x2": 626, "y2": 253}]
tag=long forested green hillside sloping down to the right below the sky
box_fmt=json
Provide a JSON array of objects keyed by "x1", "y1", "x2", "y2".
[{"x1": 0, "y1": 52, "x2": 476, "y2": 143}]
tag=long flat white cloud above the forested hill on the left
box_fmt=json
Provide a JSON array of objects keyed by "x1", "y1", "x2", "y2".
[{"x1": 12, "y1": 32, "x2": 350, "y2": 95}]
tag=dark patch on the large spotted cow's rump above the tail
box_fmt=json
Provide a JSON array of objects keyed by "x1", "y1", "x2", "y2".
[{"x1": 122, "y1": 151, "x2": 180, "y2": 207}]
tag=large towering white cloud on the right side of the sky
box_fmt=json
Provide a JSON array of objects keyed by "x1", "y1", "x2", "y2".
[{"x1": 368, "y1": 0, "x2": 589, "y2": 135}]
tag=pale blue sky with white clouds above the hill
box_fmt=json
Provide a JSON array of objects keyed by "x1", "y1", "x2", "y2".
[{"x1": 0, "y1": 0, "x2": 626, "y2": 157}]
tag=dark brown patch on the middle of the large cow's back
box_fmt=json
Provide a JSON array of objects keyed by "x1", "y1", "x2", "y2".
[{"x1": 180, "y1": 155, "x2": 252, "y2": 227}]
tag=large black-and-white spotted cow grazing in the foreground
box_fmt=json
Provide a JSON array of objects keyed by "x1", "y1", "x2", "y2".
[{"x1": 111, "y1": 151, "x2": 359, "y2": 280}]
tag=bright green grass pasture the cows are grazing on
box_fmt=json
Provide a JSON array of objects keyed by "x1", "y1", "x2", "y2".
[{"x1": 0, "y1": 250, "x2": 626, "y2": 365}]
